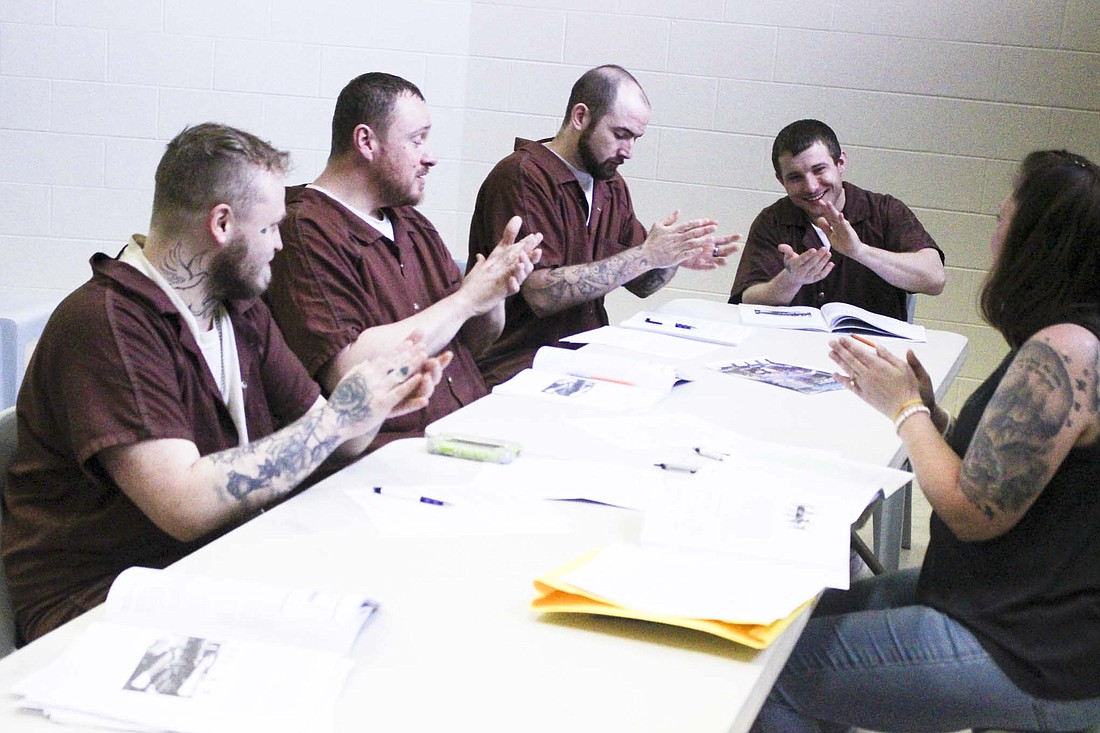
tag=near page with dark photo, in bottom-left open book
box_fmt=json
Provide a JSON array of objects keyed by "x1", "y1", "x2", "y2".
[{"x1": 12, "y1": 622, "x2": 352, "y2": 733}]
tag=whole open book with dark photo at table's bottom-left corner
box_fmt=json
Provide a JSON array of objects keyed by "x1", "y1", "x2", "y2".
[{"x1": 12, "y1": 568, "x2": 377, "y2": 733}]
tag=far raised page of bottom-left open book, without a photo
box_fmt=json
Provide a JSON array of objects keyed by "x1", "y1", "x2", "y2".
[{"x1": 105, "y1": 568, "x2": 378, "y2": 654}]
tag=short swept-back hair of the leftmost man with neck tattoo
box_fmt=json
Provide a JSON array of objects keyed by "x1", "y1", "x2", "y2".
[{"x1": 152, "y1": 122, "x2": 289, "y2": 231}]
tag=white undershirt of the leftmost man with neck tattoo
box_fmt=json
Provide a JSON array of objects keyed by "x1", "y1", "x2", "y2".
[{"x1": 119, "y1": 234, "x2": 249, "y2": 446}]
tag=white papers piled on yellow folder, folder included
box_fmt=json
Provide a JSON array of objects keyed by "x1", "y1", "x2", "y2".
[{"x1": 531, "y1": 441, "x2": 912, "y2": 648}]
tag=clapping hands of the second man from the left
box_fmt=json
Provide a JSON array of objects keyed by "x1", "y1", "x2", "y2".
[{"x1": 459, "y1": 212, "x2": 542, "y2": 316}]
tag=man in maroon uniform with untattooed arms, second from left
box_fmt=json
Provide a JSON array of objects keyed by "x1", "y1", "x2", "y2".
[{"x1": 267, "y1": 73, "x2": 539, "y2": 450}]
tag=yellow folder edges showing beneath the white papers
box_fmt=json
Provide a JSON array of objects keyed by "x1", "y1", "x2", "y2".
[{"x1": 531, "y1": 550, "x2": 813, "y2": 649}]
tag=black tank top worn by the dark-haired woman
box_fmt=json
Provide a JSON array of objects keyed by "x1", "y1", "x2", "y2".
[{"x1": 917, "y1": 309, "x2": 1100, "y2": 700}]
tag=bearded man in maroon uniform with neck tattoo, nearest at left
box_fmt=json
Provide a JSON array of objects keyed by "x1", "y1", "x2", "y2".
[{"x1": 2, "y1": 123, "x2": 446, "y2": 641}]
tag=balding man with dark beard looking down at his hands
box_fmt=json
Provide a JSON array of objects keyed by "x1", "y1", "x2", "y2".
[{"x1": 470, "y1": 65, "x2": 739, "y2": 386}]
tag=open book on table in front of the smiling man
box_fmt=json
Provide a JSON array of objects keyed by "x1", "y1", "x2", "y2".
[{"x1": 738, "y1": 303, "x2": 927, "y2": 341}]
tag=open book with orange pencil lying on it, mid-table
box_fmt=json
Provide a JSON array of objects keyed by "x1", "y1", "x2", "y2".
[{"x1": 493, "y1": 347, "x2": 682, "y2": 408}]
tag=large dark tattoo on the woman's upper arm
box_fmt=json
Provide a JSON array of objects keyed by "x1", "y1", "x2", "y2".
[{"x1": 959, "y1": 341, "x2": 1077, "y2": 519}]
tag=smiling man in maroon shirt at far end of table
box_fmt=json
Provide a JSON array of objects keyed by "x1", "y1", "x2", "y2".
[{"x1": 729, "y1": 120, "x2": 946, "y2": 320}]
